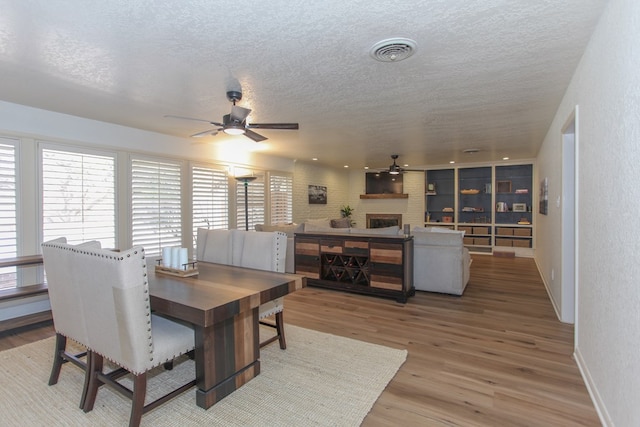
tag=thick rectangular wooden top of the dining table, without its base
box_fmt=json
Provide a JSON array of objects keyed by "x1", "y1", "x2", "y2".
[{"x1": 148, "y1": 262, "x2": 306, "y2": 327}]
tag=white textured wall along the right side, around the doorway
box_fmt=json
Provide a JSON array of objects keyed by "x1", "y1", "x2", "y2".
[{"x1": 536, "y1": 0, "x2": 640, "y2": 427}]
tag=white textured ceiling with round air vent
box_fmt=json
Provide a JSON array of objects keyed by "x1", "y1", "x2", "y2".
[{"x1": 0, "y1": 0, "x2": 607, "y2": 168}]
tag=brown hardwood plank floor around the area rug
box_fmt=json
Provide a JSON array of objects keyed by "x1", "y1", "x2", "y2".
[{"x1": 0, "y1": 255, "x2": 600, "y2": 427}]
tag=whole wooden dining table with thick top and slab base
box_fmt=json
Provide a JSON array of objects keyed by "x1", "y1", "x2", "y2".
[{"x1": 148, "y1": 261, "x2": 306, "y2": 409}]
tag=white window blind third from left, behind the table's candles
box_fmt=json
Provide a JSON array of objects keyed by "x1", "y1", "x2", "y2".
[{"x1": 131, "y1": 158, "x2": 182, "y2": 256}]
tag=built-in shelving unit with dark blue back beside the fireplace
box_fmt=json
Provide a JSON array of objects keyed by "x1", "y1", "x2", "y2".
[{"x1": 425, "y1": 163, "x2": 534, "y2": 256}]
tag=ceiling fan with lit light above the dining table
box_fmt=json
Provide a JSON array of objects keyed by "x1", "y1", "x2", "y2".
[{"x1": 165, "y1": 91, "x2": 299, "y2": 142}]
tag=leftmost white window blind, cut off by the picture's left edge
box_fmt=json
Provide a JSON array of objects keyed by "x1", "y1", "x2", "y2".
[{"x1": 0, "y1": 138, "x2": 17, "y2": 289}]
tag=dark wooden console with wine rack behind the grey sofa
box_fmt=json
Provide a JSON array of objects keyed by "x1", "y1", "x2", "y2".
[{"x1": 295, "y1": 233, "x2": 415, "y2": 303}]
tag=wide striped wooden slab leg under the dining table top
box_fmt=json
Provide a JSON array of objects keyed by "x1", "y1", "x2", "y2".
[{"x1": 195, "y1": 307, "x2": 260, "y2": 409}]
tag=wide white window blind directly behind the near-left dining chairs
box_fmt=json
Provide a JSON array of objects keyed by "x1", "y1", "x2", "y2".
[{"x1": 42, "y1": 147, "x2": 116, "y2": 248}]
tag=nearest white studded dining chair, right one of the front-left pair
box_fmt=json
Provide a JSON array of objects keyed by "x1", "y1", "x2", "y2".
[{"x1": 43, "y1": 243, "x2": 195, "y2": 426}]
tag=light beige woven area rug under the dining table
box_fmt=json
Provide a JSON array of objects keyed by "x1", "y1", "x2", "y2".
[{"x1": 0, "y1": 325, "x2": 407, "y2": 427}]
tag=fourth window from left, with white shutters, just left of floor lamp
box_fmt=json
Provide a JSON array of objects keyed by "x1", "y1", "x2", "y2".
[{"x1": 191, "y1": 166, "x2": 229, "y2": 249}]
